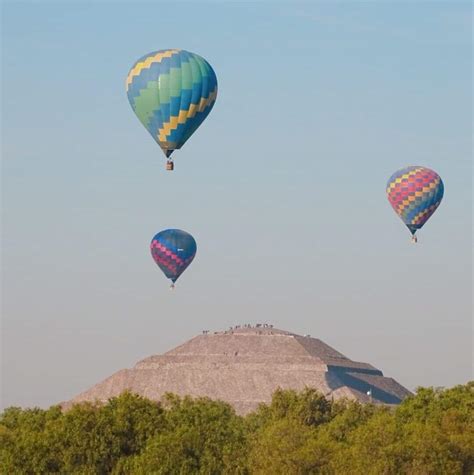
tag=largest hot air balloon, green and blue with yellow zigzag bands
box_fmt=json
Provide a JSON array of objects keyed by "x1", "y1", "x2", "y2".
[{"x1": 126, "y1": 49, "x2": 217, "y2": 170}]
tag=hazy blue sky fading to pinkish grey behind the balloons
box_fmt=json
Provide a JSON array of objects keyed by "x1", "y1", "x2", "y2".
[{"x1": 2, "y1": 1, "x2": 472, "y2": 406}]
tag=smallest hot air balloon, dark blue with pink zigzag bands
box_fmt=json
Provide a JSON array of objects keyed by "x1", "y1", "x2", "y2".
[{"x1": 150, "y1": 229, "x2": 197, "y2": 289}]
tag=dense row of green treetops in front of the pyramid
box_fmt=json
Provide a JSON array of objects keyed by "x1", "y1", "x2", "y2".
[{"x1": 0, "y1": 382, "x2": 474, "y2": 475}]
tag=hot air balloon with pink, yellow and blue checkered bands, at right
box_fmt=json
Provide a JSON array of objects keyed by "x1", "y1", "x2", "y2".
[{"x1": 387, "y1": 166, "x2": 444, "y2": 242}]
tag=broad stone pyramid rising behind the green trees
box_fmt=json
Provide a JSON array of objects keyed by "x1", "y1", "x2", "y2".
[{"x1": 65, "y1": 324, "x2": 410, "y2": 414}]
